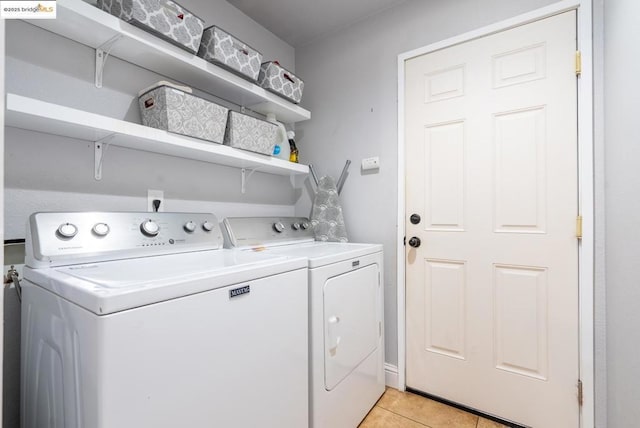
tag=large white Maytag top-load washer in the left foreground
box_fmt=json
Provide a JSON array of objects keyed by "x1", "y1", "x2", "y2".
[{"x1": 21, "y1": 212, "x2": 309, "y2": 428}]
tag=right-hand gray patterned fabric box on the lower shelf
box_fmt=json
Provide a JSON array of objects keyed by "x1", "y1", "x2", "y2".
[{"x1": 224, "y1": 111, "x2": 278, "y2": 156}]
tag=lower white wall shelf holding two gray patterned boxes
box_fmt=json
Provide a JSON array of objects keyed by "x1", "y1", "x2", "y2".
[{"x1": 5, "y1": 94, "x2": 309, "y2": 179}]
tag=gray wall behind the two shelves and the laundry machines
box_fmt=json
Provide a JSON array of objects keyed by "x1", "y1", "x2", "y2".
[{"x1": 0, "y1": 0, "x2": 296, "y2": 428}]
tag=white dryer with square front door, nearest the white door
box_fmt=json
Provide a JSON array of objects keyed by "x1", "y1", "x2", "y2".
[{"x1": 223, "y1": 217, "x2": 385, "y2": 428}]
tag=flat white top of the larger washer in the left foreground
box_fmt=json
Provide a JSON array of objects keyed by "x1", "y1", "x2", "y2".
[{"x1": 24, "y1": 250, "x2": 307, "y2": 315}]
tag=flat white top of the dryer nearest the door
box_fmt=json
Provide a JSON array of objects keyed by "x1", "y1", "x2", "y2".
[{"x1": 256, "y1": 241, "x2": 382, "y2": 269}]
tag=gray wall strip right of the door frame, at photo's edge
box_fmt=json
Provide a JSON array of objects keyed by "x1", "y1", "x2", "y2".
[{"x1": 604, "y1": 0, "x2": 640, "y2": 428}]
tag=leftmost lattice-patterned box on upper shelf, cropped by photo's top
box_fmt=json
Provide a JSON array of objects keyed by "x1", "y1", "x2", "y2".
[{"x1": 98, "y1": 0, "x2": 204, "y2": 53}]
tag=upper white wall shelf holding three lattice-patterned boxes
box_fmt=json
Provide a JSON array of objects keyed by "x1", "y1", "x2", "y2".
[{"x1": 27, "y1": 0, "x2": 311, "y2": 123}]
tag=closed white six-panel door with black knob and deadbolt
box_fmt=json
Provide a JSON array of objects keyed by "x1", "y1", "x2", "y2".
[{"x1": 404, "y1": 12, "x2": 579, "y2": 428}]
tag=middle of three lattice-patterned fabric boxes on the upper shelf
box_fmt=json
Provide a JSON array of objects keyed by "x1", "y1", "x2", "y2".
[{"x1": 198, "y1": 25, "x2": 262, "y2": 82}]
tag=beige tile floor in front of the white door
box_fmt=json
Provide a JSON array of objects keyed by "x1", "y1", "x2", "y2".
[{"x1": 359, "y1": 388, "x2": 506, "y2": 428}]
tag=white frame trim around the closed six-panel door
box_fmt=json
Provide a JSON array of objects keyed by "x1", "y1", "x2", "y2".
[{"x1": 396, "y1": 0, "x2": 595, "y2": 427}]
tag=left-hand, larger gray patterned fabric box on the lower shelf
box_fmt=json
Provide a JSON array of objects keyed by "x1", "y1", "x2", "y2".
[{"x1": 138, "y1": 82, "x2": 229, "y2": 144}]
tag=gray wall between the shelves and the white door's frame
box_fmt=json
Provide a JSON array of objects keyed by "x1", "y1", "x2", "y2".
[{"x1": 296, "y1": 0, "x2": 553, "y2": 365}]
